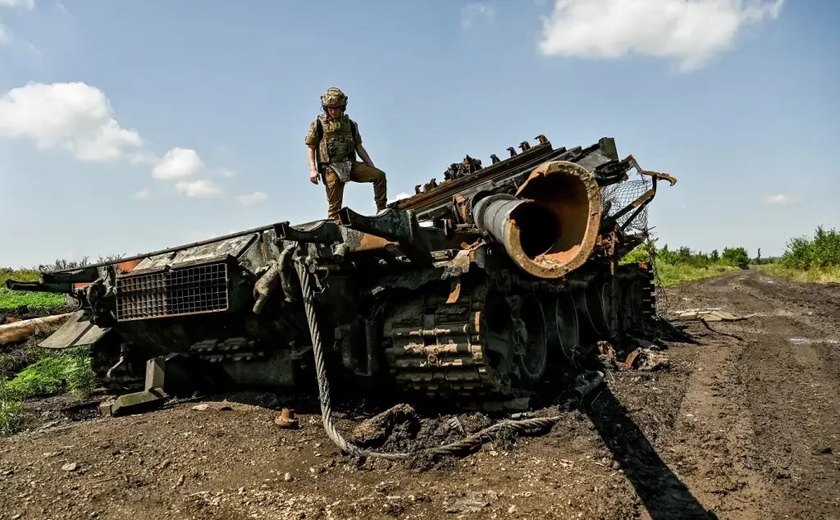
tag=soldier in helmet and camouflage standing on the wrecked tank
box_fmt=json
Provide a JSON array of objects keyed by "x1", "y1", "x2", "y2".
[{"x1": 305, "y1": 87, "x2": 388, "y2": 220}]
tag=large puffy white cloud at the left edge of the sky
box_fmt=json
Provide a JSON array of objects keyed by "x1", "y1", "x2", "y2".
[{"x1": 0, "y1": 83, "x2": 143, "y2": 161}]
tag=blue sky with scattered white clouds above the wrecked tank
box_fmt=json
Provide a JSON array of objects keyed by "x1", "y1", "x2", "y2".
[{"x1": 0, "y1": 0, "x2": 840, "y2": 267}]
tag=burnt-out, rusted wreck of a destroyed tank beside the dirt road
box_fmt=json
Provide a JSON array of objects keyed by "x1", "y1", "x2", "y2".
[{"x1": 8, "y1": 135, "x2": 676, "y2": 414}]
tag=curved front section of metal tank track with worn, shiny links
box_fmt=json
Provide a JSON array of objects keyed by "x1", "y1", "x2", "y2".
[{"x1": 384, "y1": 287, "x2": 509, "y2": 399}]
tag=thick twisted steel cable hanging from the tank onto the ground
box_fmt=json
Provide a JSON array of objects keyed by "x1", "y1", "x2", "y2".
[{"x1": 295, "y1": 259, "x2": 576, "y2": 460}]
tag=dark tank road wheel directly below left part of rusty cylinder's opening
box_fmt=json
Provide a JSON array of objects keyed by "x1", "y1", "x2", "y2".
[{"x1": 515, "y1": 294, "x2": 548, "y2": 386}]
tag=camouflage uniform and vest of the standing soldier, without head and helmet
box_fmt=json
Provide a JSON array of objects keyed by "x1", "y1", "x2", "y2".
[{"x1": 305, "y1": 91, "x2": 388, "y2": 220}]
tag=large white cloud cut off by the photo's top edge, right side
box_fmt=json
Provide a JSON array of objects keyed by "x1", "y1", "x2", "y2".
[{"x1": 539, "y1": 0, "x2": 784, "y2": 71}]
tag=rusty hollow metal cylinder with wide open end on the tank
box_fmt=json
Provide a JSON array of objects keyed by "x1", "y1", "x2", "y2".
[{"x1": 473, "y1": 161, "x2": 601, "y2": 279}]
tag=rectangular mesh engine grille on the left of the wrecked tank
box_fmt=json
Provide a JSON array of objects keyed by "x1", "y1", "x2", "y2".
[{"x1": 117, "y1": 263, "x2": 229, "y2": 321}]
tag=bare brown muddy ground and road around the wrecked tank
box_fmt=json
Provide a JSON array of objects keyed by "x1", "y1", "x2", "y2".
[{"x1": 0, "y1": 271, "x2": 840, "y2": 520}]
